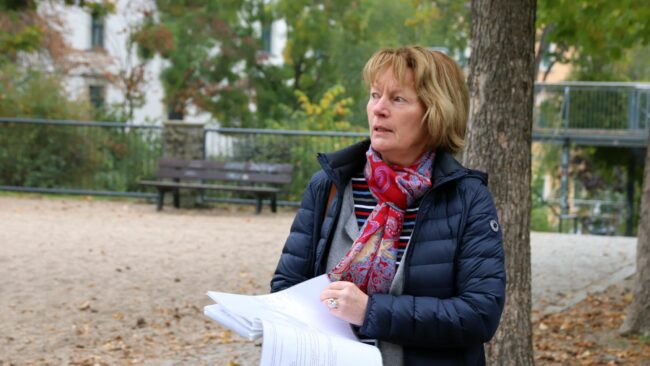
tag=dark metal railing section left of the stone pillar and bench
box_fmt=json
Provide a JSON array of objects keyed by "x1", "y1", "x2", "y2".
[{"x1": 0, "y1": 118, "x2": 162, "y2": 197}]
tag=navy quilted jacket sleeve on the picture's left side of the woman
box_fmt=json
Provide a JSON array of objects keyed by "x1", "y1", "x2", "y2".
[{"x1": 271, "y1": 177, "x2": 317, "y2": 292}]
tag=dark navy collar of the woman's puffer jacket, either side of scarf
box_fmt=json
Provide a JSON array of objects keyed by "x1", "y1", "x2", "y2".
[{"x1": 318, "y1": 139, "x2": 487, "y2": 189}]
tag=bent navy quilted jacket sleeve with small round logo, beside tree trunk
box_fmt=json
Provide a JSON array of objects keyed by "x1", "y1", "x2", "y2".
[{"x1": 360, "y1": 184, "x2": 506, "y2": 348}]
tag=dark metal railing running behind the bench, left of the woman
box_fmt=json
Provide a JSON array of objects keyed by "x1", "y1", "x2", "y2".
[{"x1": 0, "y1": 118, "x2": 366, "y2": 205}]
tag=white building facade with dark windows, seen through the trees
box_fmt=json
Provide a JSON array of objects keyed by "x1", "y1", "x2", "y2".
[{"x1": 39, "y1": 0, "x2": 286, "y2": 124}]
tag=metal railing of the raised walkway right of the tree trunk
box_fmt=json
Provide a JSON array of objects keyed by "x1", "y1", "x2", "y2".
[{"x1": 533, "y1": 82, "x2": 650, "y2": 147}]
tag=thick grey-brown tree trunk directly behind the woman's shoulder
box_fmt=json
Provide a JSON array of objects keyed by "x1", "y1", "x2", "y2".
[{"x1": 463, "y1": 0, "x2": 536, "y2": 366}]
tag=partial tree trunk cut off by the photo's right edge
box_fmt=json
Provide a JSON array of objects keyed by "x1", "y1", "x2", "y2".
[{"x1": 621, "y1": 142, "x2": 650, "y2": 336}]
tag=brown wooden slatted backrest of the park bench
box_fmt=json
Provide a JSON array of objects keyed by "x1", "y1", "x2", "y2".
[{"x1": 158, "y1": 158, "x2": 293, "y2": 184}]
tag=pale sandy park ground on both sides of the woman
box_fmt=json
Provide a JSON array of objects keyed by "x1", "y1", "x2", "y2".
[{"x1": 0, "y1": 196, "x2": 635, "y2": 365}]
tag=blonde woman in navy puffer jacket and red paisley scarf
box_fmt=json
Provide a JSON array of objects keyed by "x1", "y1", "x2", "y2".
[{"x1": 271, "y1": 46, "x2": 505, "y2": 365}]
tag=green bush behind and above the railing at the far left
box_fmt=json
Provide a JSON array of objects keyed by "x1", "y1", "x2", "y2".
[{"x1": 0, "y1": 64, "x2": 160, "y2": 191}]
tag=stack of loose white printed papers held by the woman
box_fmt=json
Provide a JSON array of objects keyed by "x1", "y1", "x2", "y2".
[{"x1": 204, "y1": 275, "x2": 382, "y2": 366}]
